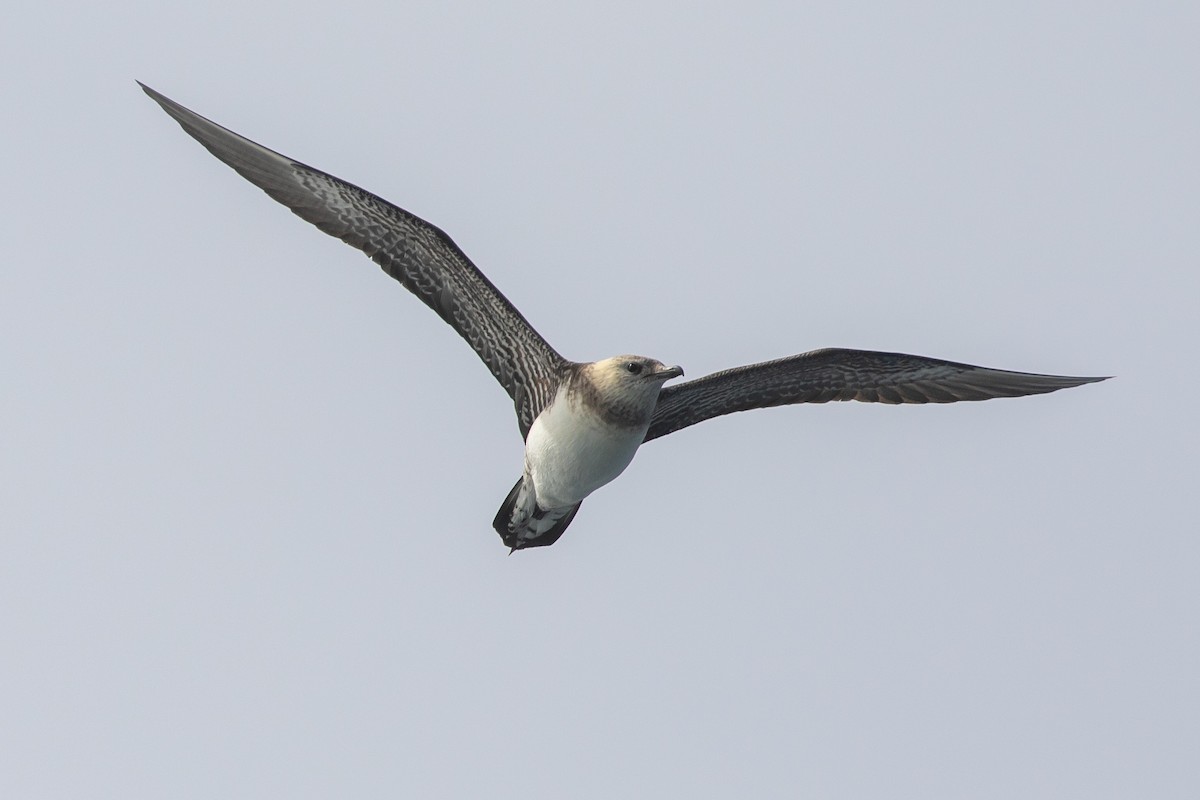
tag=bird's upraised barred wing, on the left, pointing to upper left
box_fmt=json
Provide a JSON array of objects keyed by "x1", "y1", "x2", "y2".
[{"x1": 138, "y1": 83, "x2": 566, "y2": 435}]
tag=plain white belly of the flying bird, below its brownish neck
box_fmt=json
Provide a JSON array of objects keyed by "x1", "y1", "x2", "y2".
[{"x1": 526, "y1": 397, "x2": 646, "y2": 509}]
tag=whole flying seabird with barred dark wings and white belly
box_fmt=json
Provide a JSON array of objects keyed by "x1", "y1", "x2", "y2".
[{"x1": 139, "y1": 82, "x2": 1104, "y2": 552}]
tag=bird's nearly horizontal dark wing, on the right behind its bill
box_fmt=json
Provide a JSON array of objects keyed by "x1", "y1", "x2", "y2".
[{"x1": 644, "y1": 348, "x2": 1105, "y2": 441}]
